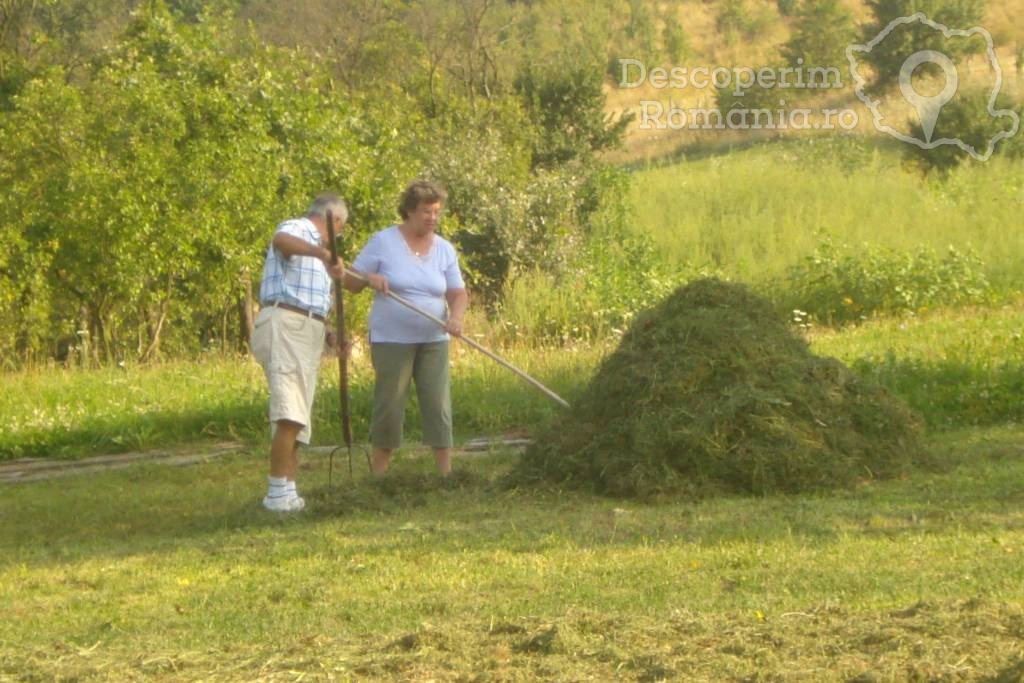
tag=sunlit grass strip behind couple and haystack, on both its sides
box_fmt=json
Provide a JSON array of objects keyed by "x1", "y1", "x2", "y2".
[{"x1": 6, "y1": 301, "x2": 1024, "y2": 460}]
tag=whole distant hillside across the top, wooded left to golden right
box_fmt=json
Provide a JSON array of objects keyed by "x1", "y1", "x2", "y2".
[{"x1": 0, "y1": 0, "x2": 1024, "y2": 162}]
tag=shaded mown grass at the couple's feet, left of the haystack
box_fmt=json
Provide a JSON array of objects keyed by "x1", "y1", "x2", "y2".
[{"x1": 0, "y1": 449, "x2": 507, "y2": 567}]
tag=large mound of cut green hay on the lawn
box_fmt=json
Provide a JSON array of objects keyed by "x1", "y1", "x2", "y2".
[{"x1": 514, "y1": 280, "x2": 924, "y2": 497}]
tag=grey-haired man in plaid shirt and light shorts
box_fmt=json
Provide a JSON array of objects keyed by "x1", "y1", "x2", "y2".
[{"x1": 252, "y1": 194, "x2": 348, "y2": 512}]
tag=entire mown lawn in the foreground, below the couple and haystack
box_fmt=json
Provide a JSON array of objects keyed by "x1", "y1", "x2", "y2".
[{"x1": 0, "y1": 428, "x2": 1024, "y2": 680}]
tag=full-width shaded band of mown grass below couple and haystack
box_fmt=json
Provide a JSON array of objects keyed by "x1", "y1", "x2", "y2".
[{"x1": 0, "y1": 428, "x2": 1024, "y2": 566}]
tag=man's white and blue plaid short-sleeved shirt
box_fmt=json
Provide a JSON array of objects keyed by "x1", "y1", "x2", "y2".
[{"x1": 259, "y1": 218, "x2": 332, "y2": 316}]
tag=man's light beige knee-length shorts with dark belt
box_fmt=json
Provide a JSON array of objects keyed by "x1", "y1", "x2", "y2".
[{"x1": 252, "y1": 307, "x2": 326, "y2": 443}]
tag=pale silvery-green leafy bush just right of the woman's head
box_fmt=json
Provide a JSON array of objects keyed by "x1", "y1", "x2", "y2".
[{"x1": 424, "y1": 90, "x2": 625, "y2": 310}]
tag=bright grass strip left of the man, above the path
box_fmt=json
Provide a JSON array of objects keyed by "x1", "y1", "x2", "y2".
[{"x1": 0, "y1": 359, "x2": 266, "y2": 460}]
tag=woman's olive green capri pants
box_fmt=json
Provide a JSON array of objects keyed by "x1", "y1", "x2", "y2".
[{"x1": 370, "y1": 340, "x2": 452, "y2": 450}]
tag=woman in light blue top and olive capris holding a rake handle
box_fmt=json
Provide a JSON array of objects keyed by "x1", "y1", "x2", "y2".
[{"x1": 345, "y1": 180, "x2": 469, "y2": 476}]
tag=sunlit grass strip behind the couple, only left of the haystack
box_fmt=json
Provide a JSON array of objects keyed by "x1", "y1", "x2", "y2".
[{"x1": 0, "y1": 347, "x2": 602, "y2": 461}]
